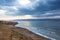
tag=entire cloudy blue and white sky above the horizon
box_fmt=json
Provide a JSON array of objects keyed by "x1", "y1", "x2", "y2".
[{"x1": 0, "y1": 0, "x2": 60, "y2": 20}]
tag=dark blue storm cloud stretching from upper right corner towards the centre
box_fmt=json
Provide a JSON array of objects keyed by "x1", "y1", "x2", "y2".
[{"x1": 15, "y1": 0, "x2": 60, "y2": 15}]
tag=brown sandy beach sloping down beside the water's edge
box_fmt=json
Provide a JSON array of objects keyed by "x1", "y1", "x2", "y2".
[{"x1": 0, "y1": 21, "x2": 50, "y2": 40}]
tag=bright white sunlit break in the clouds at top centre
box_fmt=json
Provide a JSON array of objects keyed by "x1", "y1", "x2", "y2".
[{"x1": 17, "y1": 0, "x2": 41, "y2": 10}]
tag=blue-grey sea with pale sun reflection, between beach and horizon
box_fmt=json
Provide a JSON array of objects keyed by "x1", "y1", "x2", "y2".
[{"x1": 11, "y1": 19, "x2": 60, "y2": 40}]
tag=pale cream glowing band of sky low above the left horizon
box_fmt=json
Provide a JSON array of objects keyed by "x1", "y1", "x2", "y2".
[{"x1": 0, "y1": 15, "x2": 33, "y2": 20}]
